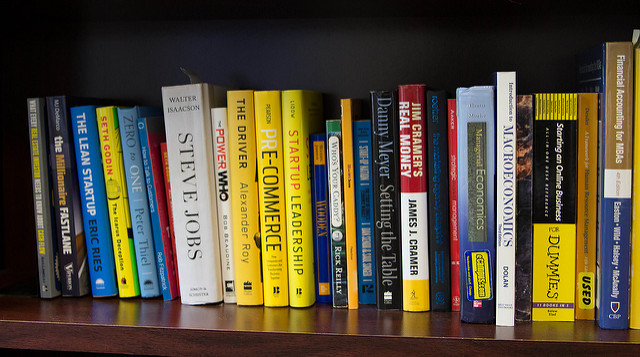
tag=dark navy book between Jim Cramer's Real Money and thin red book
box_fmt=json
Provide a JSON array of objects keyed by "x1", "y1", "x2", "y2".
[{"x1": 425, "y1": 87, "x2": 451, "y2": 311}]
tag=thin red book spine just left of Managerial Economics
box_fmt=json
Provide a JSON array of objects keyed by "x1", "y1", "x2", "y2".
[{"x1": 447, "y1": 98, "x2": 460, "y2": 311}]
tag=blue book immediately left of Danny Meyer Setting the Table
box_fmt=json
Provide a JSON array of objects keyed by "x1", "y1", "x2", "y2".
[{"x1": 353, "y1": 120, "x2": 376, "y2": 304}]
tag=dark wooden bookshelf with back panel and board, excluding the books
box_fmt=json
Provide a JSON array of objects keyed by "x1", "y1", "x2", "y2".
[{"x1": 0, "y1": 0, "x2": 640, "y2": 355}]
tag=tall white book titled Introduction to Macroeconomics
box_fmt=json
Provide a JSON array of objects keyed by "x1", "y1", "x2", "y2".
[{"x1": 494, "y1": 72, "x2": 517, "y2": 326}]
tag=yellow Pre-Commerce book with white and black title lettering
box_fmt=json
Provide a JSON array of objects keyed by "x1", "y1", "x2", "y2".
[{"x1": 254, "y1": 91, "x2": 289, "y2": 306}]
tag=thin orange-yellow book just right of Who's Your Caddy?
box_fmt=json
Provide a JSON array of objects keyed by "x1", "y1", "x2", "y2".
[{"x1": 340, "y1": 99, "x2": 360, "y2": 309}]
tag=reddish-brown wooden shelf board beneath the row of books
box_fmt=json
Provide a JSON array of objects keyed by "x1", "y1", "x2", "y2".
[{"x1": 0, "y1": 296, "x2": 640, "y2": 356}]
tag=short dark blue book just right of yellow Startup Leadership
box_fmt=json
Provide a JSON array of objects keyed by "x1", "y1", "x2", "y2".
[{"x1": 309, "y1": 133, "x2": 333, "y2": 303}]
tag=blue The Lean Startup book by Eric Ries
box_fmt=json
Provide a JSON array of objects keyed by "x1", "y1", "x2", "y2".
[{"x1": 70, "y1": 106, "x2": 118, "y2": 297}]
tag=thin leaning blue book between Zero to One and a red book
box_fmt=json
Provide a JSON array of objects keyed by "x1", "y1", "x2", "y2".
[{"x1": 138, "y1": 118, "x2": 175, "y2": 300}]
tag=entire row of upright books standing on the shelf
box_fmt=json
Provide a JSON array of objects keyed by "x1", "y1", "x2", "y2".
[{"x1": 27, "y1": 36, "x2": 640, "y2": 329}]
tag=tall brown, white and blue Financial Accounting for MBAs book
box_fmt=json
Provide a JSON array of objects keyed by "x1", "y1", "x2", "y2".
[{"x1": 578, "y1": 41, "x2": 633, "y2": 329}]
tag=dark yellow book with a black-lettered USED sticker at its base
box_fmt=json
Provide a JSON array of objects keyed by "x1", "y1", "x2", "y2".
[{"x1": 575, "y1": 93, "x2": 598, "y2": 320}]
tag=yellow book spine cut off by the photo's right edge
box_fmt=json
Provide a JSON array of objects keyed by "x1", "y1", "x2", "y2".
[{"x1": 629, "y1": 30, "x2": 640, "y2": 329}]
